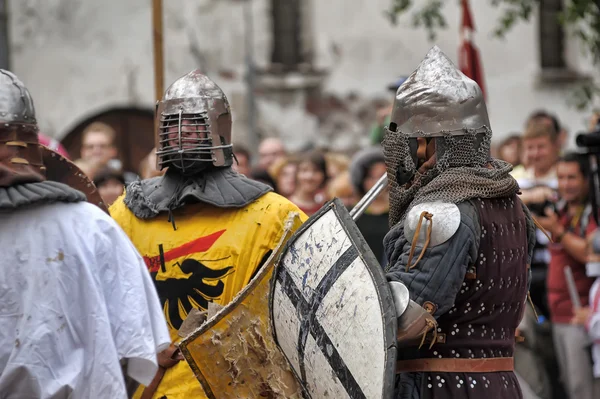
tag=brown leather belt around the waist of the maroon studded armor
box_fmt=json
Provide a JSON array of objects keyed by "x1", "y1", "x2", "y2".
[{"x1": 396, "y1": 357, "x2": 515, "y2": 374}]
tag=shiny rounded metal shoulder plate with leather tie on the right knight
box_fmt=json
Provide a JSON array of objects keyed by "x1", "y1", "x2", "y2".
[{"x1": 404, "y1": 202, "x2": 460, "y2": 247}]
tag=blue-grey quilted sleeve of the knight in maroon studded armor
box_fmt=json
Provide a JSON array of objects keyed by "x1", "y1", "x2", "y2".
[{"x1": 385, "y1": 201, "x2": 481, "y2": 318}]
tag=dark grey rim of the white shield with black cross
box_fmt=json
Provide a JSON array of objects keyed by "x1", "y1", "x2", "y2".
[{"x1": 269, "y1": 198, "x2": 398, "y2": 399}]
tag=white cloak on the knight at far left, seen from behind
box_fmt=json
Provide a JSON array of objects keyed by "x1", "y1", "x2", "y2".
[{"x1": 0, "y1": 202, "x2": 170, "y2": 399}]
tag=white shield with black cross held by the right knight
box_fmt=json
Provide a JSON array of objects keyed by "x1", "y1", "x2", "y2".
[{"x1": 270, "y1": 199, "x2": 396, "y2": 399}]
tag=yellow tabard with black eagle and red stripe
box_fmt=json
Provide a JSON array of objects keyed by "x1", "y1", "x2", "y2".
[{"x1": 110, "y1": 193, "x2": 307, "y2": 399}]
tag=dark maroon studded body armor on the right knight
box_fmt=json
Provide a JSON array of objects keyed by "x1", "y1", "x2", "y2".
[{"x1": 386, "y1": 196, "x2": 533, "y2": 399}]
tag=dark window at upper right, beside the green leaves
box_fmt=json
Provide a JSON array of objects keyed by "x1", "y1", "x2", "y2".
[{"x1": 539, "y1": 0, "x2": 567, "y2": 70}]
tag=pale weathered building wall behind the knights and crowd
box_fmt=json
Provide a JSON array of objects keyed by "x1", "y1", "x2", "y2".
[{"x1": 9, "y1": 0, "x2": 596, "y2": 156}]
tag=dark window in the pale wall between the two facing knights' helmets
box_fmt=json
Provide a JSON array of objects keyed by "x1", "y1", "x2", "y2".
[{"x1": 271, "y1": 0, "x2": 306, "y2": 72}]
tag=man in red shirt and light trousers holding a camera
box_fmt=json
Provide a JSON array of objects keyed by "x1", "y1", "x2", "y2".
[{"x1": 538, "y1": 154, "x2": 597, "y2": 399}]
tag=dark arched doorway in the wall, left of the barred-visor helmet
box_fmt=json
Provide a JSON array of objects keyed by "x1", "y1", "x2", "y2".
[{"x1": 61, "y1": 108, "x2": 154, "y2": 173}]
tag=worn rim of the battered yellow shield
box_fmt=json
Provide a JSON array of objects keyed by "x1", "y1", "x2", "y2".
[{"x1": 177, "y1": 211, "x2": 302, "y2": 399}]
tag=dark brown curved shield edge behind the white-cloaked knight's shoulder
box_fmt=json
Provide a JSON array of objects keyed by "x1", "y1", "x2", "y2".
[{"x1": 40, "y1": 145, "x2": 108, "y2": 213}]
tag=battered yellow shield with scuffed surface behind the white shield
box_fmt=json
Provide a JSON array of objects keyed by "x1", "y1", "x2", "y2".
[{"x1": 179, "y1": 213, "x2": 302, "y2": 399}]
